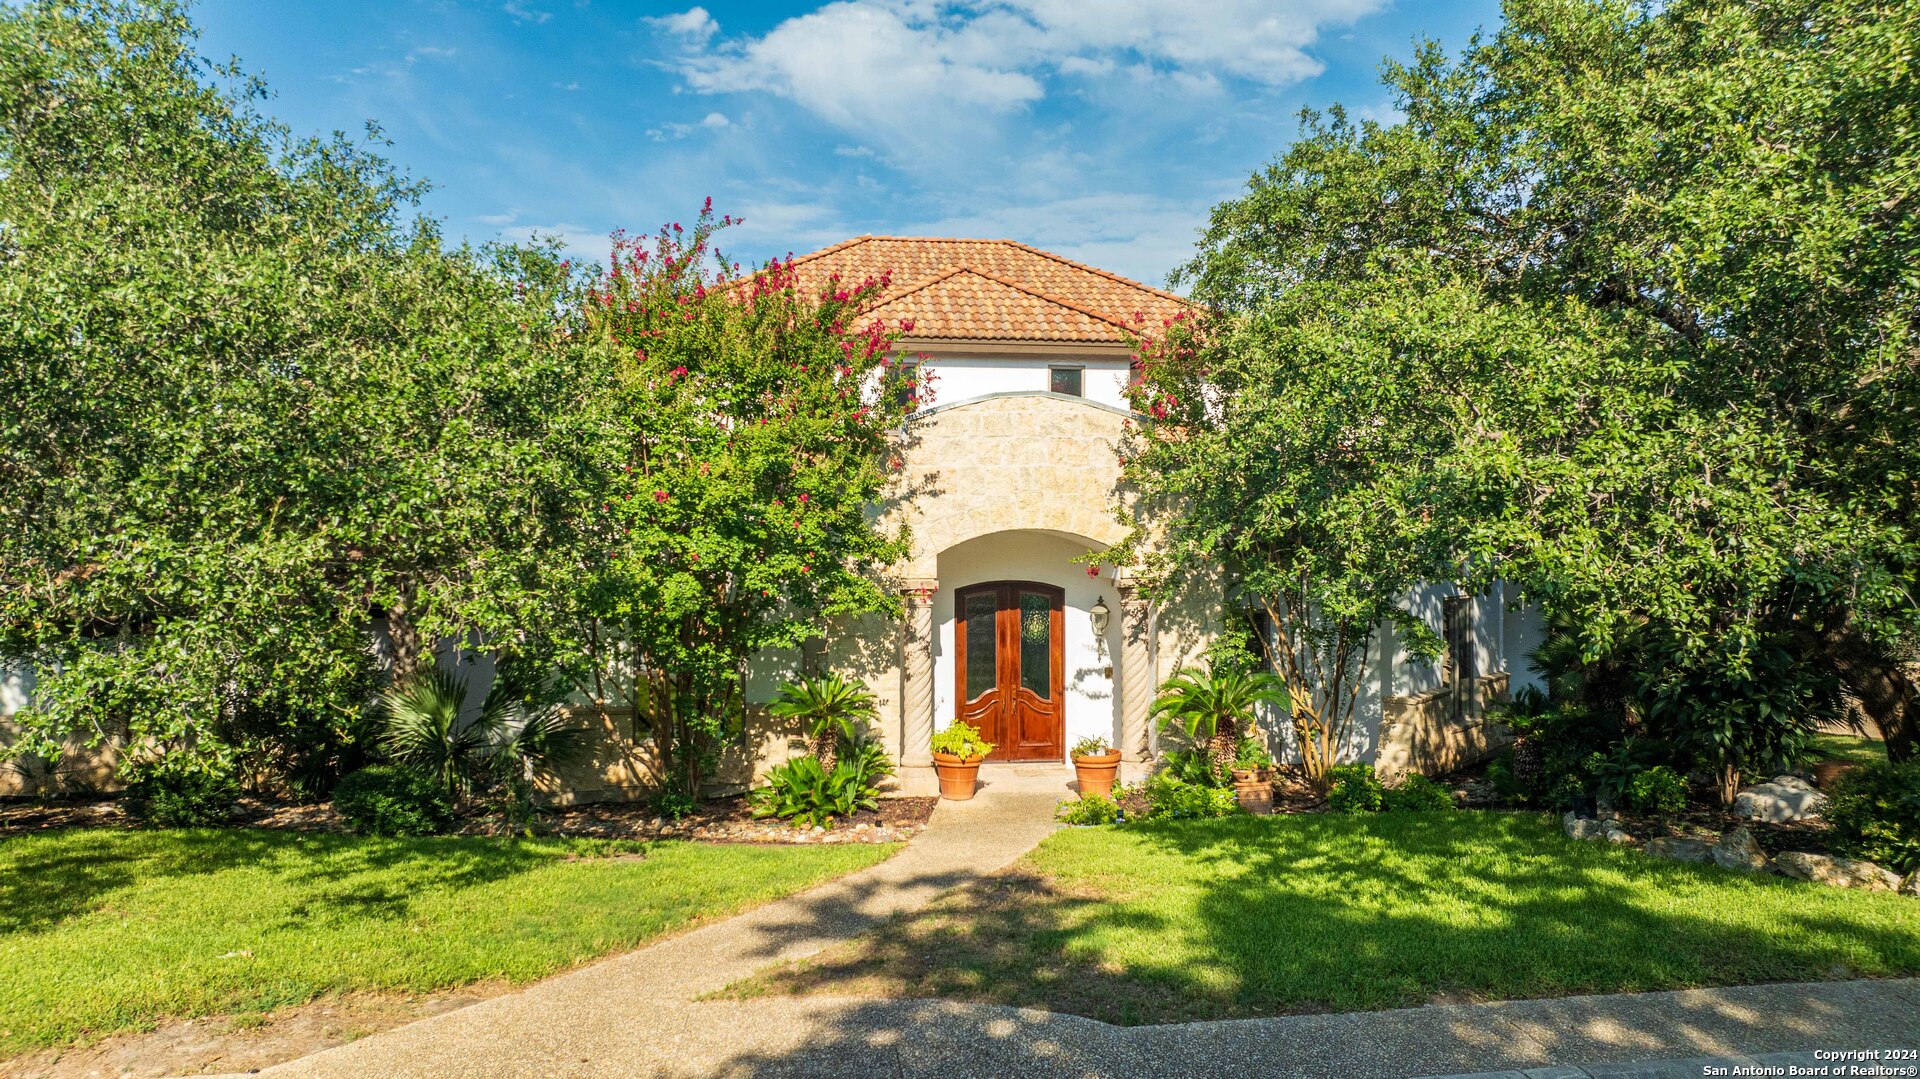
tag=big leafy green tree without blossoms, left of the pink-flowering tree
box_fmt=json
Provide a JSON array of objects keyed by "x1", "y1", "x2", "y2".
[{"x1": 0, "y1": 2, "x2": 605, "y2": 793}]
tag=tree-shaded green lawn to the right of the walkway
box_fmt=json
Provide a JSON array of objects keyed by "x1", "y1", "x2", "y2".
[{"x1": 730, "y1": 812, "x2": 1920, "y2": 1023}]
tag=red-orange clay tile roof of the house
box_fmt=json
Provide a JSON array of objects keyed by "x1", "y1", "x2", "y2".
[{"x1": 793, "y1": 236, "x2": 1188, "y2": 344}]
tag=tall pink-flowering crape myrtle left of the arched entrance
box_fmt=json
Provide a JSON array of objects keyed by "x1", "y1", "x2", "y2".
[{"x1": 551, "y1": 212, "x2": 929, "y2": 799}]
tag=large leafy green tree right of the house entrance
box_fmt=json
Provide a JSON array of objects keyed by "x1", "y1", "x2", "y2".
[{"x1": 1142, "y1": 0, "x2": 1920, "y2": 787}]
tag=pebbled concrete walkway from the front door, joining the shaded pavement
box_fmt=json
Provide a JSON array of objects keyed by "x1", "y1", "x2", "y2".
[{"x1": 243, "y1": 776, "x2": 1920, "y2": 1079}]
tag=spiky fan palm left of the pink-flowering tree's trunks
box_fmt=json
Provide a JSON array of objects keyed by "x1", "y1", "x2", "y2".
[{"x1": 380, "y1": 666, "x2": 586, "y2": 803}]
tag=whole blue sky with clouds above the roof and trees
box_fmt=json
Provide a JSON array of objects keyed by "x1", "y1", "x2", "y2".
[{"x1": 196, "y1": 0, "x2": 1500, "y2": 284}]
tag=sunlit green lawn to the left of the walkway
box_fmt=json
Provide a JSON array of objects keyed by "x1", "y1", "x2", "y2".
[{"x1": 0, "y1": 829, "x2": 893, "y2": 1058}]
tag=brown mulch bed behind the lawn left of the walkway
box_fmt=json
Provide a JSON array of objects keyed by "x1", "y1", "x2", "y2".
[{"x1": 0, "y1": 795, "x2": 939, "y2": 843}]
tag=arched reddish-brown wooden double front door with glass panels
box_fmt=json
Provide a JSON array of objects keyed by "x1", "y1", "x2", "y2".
[{"x1": 954, "y1": 580, "x2": 1066, "y2": 760}]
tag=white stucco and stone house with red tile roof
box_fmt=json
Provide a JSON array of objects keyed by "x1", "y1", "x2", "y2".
[{"x1": 0, "y1": 236, "x2": 1538, "y2": 801}]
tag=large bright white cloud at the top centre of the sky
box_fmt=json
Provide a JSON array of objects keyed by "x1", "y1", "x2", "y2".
[{"x1": 651, "y1": 0, "x2": 1386, "y2": 142}]
